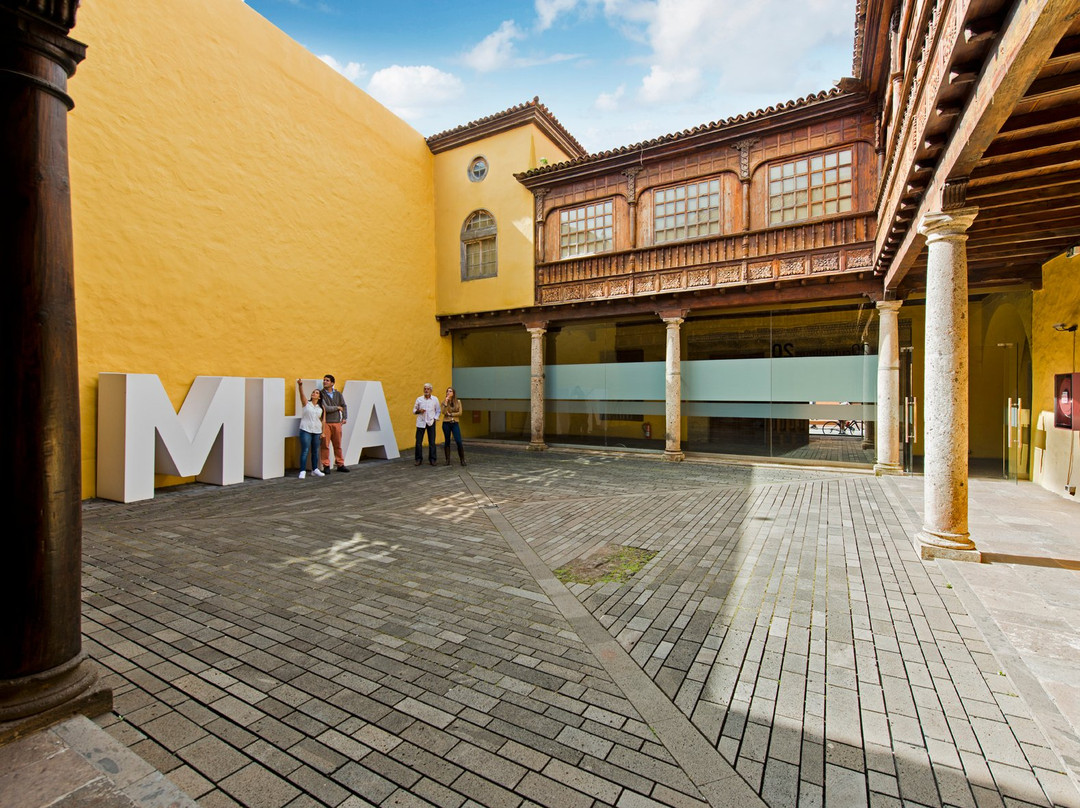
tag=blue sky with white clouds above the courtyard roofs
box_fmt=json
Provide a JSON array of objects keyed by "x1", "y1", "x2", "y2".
[{"x1": 240, "y1": 0, "x2": 855, "y2": 151}]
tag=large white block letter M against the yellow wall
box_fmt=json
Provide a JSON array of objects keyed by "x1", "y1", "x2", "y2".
[{"x1": 97, "y1": 373, "x2": 244, "y2": 502}]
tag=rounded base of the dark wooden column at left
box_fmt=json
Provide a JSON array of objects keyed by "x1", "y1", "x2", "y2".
[{"x1": 0, "y1": 654, "x2": 112, "y2": 745}]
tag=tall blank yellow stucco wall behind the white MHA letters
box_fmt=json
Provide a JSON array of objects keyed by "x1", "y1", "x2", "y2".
[{"x1": 69, "y1": 0, "x2": 450, "y2": 497}]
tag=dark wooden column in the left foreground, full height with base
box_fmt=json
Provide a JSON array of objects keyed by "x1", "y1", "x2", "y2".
[{"x1": 0, "y1": 0, "x2": 111, "y2": 743}]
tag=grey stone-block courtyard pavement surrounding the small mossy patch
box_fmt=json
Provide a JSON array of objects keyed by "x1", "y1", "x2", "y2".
[{"x1": 83, "y1": 448, "x2": 1080, "y2": 808}]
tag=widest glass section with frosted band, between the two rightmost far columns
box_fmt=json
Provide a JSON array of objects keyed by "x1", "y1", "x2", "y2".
[{"x1": 683, "y1": 301, "x2": 877, "y2": 464}]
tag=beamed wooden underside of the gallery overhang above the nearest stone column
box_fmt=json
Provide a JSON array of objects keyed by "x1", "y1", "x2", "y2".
[{"x1": 875, "y1": 0, "x2": 1080, "y2": 289}]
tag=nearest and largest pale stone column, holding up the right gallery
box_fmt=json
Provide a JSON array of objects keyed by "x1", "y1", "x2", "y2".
[{"x1": 916, "y1": 207, "x2": 980, "y2": 561}]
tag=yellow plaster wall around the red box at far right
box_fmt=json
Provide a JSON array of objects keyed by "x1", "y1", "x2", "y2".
[{"x1": 1031, "y1": 255, "x2": 1080, "y2": 494}]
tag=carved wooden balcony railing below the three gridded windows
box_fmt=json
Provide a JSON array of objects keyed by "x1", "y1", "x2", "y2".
[{"x1": 536, "y1": 213, "x2": 876, "y2": 304}]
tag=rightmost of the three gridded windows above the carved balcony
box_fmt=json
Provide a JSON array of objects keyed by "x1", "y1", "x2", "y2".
[{"x1": 769, "y1": 149, "x2": 852, "y2": 225}]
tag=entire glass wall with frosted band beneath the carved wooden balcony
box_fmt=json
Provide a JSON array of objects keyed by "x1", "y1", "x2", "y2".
[{"x1": 454, "y1": 301, "x2": 877, "y2": 464}]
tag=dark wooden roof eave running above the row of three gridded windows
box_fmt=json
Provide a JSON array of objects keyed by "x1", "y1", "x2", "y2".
[{"x1": 514, "y1": 92, "x2": 872, "y2": 190}]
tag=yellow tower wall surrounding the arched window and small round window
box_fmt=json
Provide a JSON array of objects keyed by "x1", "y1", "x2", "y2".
[{"x1": 435, "y1": 124, "x2": 569, "y2": 314}]
